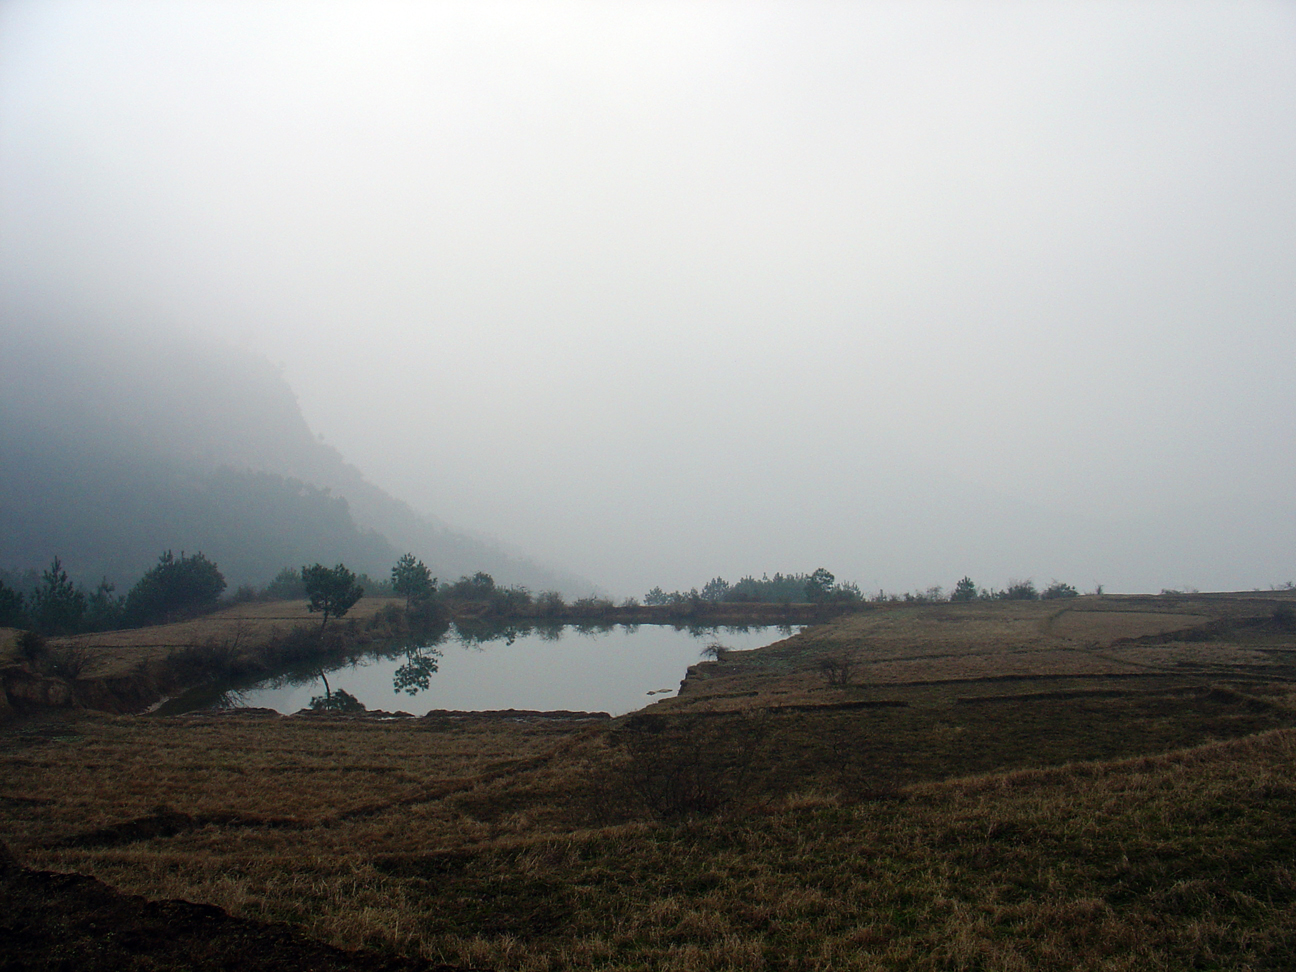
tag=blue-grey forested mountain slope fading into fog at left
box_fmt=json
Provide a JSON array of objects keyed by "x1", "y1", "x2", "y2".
[{"x1": 0, "y1": 328, "x2": 586, "y2": 591}]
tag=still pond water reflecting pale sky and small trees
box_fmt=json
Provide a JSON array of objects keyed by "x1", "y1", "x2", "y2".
[{"x1": 159, "y1": 625, "x2": 800, "y2": 715}]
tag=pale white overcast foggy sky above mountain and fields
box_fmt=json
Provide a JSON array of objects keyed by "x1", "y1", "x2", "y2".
[{"x1": 0, "y1": 0, "x2": 1296, "y2": 595}]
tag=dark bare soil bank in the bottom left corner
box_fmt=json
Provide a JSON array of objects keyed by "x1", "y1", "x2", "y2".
[{"x1": 0, "y1": 845, "x2": 476, "y2": 972}]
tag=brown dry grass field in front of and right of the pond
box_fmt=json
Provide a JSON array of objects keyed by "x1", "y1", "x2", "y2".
[{"x1": 0, "y1": 595, "x2": 1296, "y2": 969}]
